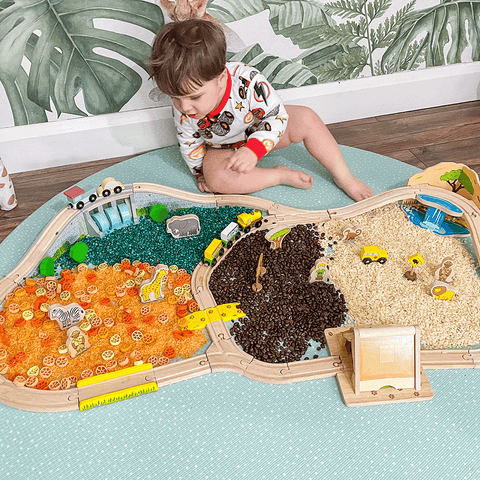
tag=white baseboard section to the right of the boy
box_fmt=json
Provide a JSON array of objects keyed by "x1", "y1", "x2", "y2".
[{"x1": 280, "y1": 62, "x2": 480, "y2": 124}]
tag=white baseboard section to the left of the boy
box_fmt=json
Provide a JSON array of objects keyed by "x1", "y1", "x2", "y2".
[{"x1": 0, "y1": 107, "x2": 176, "y2": 173}]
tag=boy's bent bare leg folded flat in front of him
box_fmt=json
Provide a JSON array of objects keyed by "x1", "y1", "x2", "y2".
[{"x1": 199, "y1": 148, "x2": 313, "y2": 193}]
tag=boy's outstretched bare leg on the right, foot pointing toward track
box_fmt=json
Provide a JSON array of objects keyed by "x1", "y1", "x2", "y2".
[{"x1": 275, "y1": 105, "x2": 373, "y2": 201}]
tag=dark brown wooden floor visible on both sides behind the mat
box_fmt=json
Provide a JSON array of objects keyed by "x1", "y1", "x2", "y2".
[{"x1": 0, "y1": 101, "x2": 480, "y2": 242}]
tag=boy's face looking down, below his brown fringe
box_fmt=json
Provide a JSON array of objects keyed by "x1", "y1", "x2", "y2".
[{"x1": 172, "y1": 69, "x2": 227, "y2": 120}]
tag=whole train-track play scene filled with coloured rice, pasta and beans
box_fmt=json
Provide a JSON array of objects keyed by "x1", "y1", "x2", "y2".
[{"x1": 0, "y1": 167, "x2": 480, "y2": 411}]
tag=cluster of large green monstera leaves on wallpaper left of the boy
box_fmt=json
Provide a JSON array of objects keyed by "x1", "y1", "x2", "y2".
[{"x1": 0, "y1": 0, "x2": 164, "y2": 125}]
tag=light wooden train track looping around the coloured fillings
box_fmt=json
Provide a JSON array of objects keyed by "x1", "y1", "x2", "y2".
[{"x1": 0, "y1": 183, "x2": 480, "y2": 411}]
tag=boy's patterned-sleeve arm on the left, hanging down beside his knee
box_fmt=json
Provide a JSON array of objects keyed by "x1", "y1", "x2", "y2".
[{"x1": 173, "y1": 108, "x2": 206, "y2": 178}]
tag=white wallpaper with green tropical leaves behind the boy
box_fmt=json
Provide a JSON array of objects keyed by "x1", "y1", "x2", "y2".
[{"x1": 0, "y1": 0, "x2": 480, "y2": 127}]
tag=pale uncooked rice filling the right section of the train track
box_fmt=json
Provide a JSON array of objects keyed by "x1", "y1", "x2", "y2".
[{"x1": 318, "y1": 204, "x2": 480, "y2": 349}]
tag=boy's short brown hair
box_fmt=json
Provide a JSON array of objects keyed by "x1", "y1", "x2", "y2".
[{"x1": 147, "y1": 18, "x2": 227, "y2": 97}]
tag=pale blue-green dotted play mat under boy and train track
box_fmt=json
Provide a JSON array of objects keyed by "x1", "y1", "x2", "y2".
[{"x1": 0, "y1": 146, "x2": 480, "y2": 480}]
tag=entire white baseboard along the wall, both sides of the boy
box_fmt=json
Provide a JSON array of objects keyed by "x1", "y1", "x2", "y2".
[{"x1": 0, "y1": 62, "x2": 480, "y2": 173}]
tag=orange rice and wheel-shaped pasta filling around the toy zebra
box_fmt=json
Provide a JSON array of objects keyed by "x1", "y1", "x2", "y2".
[{"x1": 0, "y1": 259, "x2": 207, "y2": 390}]
